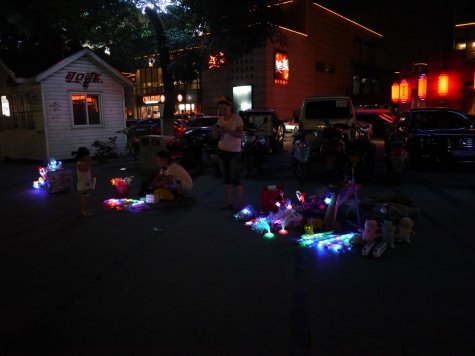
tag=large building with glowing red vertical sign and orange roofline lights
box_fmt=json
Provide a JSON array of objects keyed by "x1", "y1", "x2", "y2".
[{"x1": 201, "y1": 0, "x2": 390, "y2": 119}]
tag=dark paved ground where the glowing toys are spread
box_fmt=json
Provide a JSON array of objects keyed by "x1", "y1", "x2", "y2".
[{"x1": 0, "y1": 135, "x2": 475, "y2": 356}]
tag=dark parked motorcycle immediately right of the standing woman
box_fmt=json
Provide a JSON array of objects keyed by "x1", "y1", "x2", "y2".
[{"x1": 241, "y1": 128, "x2": 271, "y2": 177}]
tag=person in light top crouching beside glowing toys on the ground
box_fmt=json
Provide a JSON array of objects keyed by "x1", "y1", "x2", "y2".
[{"x1": 151, "y1": 151, "x2": 193, "y2": 200}]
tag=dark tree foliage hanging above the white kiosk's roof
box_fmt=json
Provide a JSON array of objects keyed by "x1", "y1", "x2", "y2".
[{"x1": 0, "y1": 0, "x2": 151, "y2": 70}]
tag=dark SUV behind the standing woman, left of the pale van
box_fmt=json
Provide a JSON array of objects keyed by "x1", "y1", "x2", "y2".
[{"x1": 239, "y1": 109, "x2": 285, "y2": 153}]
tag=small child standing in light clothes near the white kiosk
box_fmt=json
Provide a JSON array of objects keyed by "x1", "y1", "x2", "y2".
[{"x1": 73, "y1": 147, "x2": 96, "y2": 216}]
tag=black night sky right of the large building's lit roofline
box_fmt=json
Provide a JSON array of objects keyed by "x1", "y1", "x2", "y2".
[{"x1": 316, "y1": 0, "x2": 475, "y2": 69}]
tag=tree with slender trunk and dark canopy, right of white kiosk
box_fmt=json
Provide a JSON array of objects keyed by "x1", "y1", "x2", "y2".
[{"x1": 141, "y1": 0, "x2": 280, "y2": 133}]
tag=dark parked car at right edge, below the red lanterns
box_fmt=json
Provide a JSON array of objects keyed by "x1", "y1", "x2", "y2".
[{"x1": 386, "y1": 108, "x2": 475, "y2": 167}]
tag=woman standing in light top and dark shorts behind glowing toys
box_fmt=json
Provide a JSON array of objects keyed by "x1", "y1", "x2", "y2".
[{"x1": 213, "y1": 97, "x2": 244, "y2": 210}]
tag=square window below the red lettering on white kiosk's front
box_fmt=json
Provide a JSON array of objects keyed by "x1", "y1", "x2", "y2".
[{"x1": 71, "y1": 93, "x2": 102, "y2": 126}]
